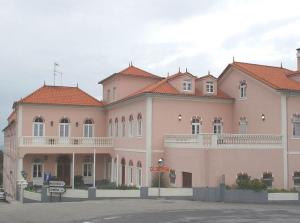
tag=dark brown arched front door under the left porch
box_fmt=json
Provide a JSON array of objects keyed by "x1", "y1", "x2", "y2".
[{"x1": 57, "y1": 156, "x2": 71, "y2": 186}]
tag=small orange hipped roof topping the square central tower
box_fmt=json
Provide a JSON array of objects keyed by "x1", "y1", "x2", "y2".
[{"x1": 98, "y1": 65, "x2": 162, "y2": 84}]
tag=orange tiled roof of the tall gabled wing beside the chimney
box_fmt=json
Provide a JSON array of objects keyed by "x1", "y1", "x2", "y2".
[{"x1": 219, "y1": 62, "x2": 300, "y2": 90}]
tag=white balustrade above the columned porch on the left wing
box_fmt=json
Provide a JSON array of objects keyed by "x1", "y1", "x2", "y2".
[{"x1": 19, "y1": 136, "x2": 113, "y2": 147}]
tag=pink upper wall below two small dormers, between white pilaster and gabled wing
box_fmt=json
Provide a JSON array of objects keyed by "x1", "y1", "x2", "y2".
[{"x1": 152, "y1": 97, "x2": 232, "y2": 149}]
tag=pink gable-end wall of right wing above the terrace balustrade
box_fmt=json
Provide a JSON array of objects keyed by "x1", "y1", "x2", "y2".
[{"x1": 218, "y1": 68, "x2": 281, "y2": 134}]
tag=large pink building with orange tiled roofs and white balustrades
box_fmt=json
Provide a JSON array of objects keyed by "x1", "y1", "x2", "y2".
[{"x1": 4, "y1": 49, "x2": 300, "y2": 197}]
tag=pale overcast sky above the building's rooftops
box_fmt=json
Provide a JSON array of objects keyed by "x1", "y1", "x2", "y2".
[{"x1": 0, "y1": 0, "x2": 300, "y2": 144}]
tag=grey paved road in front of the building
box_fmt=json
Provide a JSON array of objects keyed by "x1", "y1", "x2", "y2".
[{"x1": 0, "y1": 199, "x2": 300, "y2": 223}]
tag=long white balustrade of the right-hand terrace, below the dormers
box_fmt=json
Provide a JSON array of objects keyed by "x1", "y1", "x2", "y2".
[{"x1": 164, "y1": 134, "x2": 283, "y2": 149}]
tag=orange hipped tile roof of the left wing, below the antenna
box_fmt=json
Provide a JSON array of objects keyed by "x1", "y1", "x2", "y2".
[{"x1": 18, "y1": 85, "x2": 103, "y2": 106}]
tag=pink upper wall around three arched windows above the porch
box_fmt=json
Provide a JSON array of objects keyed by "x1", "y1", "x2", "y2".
[{"x1": 22, "y1": 105, "x2": 105, "y2": 137}]
